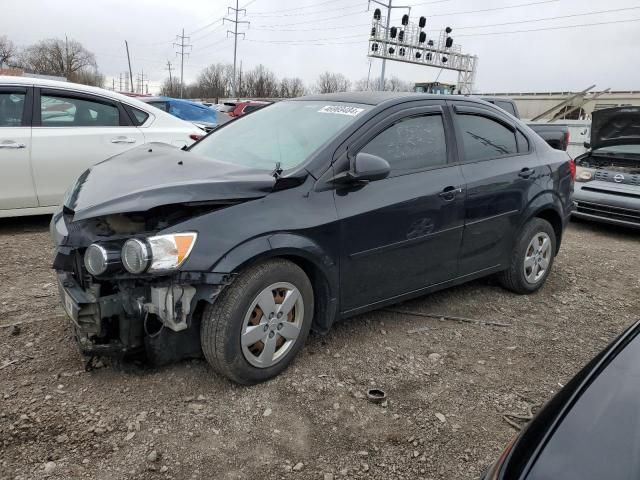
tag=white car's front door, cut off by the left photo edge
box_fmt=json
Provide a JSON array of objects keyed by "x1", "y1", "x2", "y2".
[{"x1": 0, "y1": 86, "x2": 38, "y2": 210}]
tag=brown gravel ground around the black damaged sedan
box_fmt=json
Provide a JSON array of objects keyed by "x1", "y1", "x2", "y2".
[{"x1": 0, "y1": 218, "x2": 640, "y2": 480}]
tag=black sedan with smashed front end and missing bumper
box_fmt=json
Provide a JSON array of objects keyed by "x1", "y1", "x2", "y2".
[{"x1": 51, "y1": 93, "x2": 575, "y2": 384}]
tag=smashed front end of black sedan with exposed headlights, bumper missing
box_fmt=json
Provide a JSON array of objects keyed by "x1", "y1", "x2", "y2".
[{"x1": 51, "y1": 202, "x2": 234, "y2": 364}]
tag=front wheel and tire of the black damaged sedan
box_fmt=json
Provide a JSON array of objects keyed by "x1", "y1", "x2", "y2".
[{"x1": 200, "y1": 259, "x2": 314, "y2": 385}]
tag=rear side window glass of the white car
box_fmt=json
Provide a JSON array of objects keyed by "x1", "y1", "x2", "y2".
[{"x1": 40, "y1": 95, "x2": 120, "y2": 127}]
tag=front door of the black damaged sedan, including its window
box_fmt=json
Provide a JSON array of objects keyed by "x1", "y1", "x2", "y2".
[{"x1": 335, "y1": 105, "x2": 464, "y2": 313}]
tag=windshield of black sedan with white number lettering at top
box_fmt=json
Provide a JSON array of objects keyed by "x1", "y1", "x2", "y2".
[{"x1": 191, "y1": 101, "x2": 371, "y2": 170}]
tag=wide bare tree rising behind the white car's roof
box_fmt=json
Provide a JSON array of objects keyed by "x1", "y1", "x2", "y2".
[{"x1": 20, "y1": 38, "x2": 100, "y2": 85}]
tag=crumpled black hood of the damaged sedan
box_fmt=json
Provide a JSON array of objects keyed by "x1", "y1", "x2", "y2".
[{"x1": 65, "y1": 143, "x2": 276, "y2": 221}]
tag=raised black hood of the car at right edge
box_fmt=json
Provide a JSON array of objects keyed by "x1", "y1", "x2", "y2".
[{"x1": 591, "y1": 107, "x2": 640, "y2": 149}]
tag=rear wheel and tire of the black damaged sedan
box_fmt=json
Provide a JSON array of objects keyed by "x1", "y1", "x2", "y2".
[{"x1": 498, "y1": 217, "x2": 556, "y2": 294}]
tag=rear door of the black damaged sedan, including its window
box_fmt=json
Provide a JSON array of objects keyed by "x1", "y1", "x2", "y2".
[{"x1": 449, "y1": 101, "x2": 549, "y2": 275}]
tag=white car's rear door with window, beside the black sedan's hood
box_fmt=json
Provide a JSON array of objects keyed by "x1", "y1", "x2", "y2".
[{"x1": 31, "y1": 88, "x2": 144, "y2": 206}]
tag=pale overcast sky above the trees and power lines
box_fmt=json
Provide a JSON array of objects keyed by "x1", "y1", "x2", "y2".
[{"x1": 5, "y1": 0, "x2": 640, "y2": 92}]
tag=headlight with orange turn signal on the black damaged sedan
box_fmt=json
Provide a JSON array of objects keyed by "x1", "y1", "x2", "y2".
[{"x1": 122, "y1": 232, "x2": 198, "y2": 274}]
